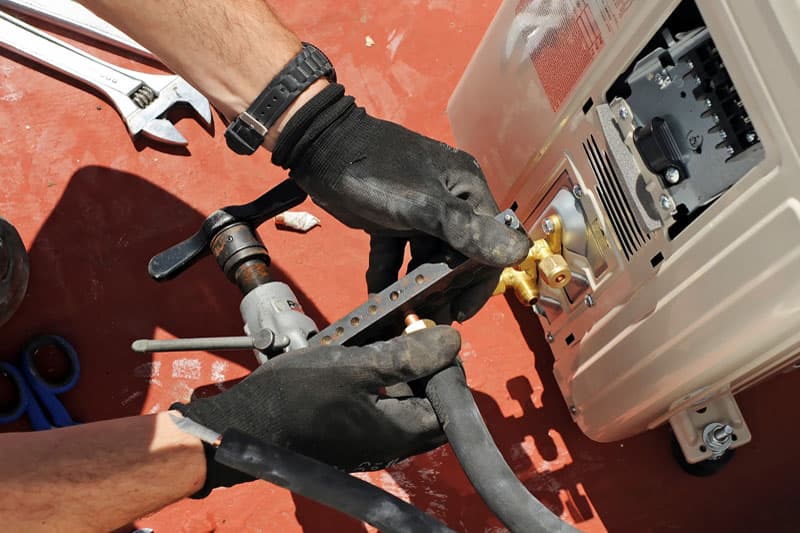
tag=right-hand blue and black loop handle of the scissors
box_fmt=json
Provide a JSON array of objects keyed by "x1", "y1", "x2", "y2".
[{"x1": 20, "y1": 335, "x2": 81, "y2": 427}]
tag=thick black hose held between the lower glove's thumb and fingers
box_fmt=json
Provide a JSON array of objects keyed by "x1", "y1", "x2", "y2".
[{"x1": 425, "y1": 366, "x2": 578, "y2": 533}]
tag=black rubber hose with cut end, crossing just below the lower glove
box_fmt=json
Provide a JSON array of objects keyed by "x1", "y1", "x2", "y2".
[{"x1": 214, "y1": 429, "x2": 453, "y2": 533}]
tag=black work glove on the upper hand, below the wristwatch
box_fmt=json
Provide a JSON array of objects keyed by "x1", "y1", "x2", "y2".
[{"x1": 272, "y1": 84, "x2": 530, "y2": 321}]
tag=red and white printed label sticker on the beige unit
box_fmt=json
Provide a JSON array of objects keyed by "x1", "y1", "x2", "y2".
[{"x1": 516, "y1": 0, "x2": 632, "y2": 111}]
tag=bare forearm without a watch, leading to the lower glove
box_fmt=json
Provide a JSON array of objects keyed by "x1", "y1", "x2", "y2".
[{"x1": 0, "y1": 413, "x2": 205, "y2": 531}]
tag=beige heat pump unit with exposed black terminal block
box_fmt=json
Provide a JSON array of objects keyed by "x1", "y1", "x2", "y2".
[{"x1": 448, "y1": 0, "x2": 800, "y2": 474}]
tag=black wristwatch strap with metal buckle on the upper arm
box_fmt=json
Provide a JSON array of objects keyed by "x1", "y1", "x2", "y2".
[{"x1": 225, "y1": 43, "x2": 336, "y2": 155}]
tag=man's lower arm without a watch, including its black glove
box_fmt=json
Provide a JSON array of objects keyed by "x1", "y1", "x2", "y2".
[{"x1": 0, "y1": 326, "x2": 461, "y2": 533}]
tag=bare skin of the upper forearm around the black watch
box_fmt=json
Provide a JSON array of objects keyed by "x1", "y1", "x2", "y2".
[{"x1": 74, "y1": 0, "x2": 325, "y2": 148}]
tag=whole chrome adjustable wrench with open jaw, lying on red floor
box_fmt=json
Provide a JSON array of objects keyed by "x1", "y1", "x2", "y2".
[{"x1": 0, "y1": 11, "x2": 211, "y2": 145}]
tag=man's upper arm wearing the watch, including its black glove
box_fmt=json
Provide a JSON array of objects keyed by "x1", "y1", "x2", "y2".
[{"x1": 78, "y1": 0, "x2": 530, "y2": 296}]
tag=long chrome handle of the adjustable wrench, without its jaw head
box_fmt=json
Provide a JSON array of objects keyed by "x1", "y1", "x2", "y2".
[{"x1": 0, "y1": 11, "x2": 142, "y2": 98}]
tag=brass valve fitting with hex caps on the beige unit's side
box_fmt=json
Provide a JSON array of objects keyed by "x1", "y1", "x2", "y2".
[{"x1": 494, "y1": 215, "x2": 572, "y2": 305}]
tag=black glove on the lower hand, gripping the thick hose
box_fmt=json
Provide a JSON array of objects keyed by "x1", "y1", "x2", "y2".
[{"x1": 172, "y1": 326, "x2": 461, "y2": 497}]
